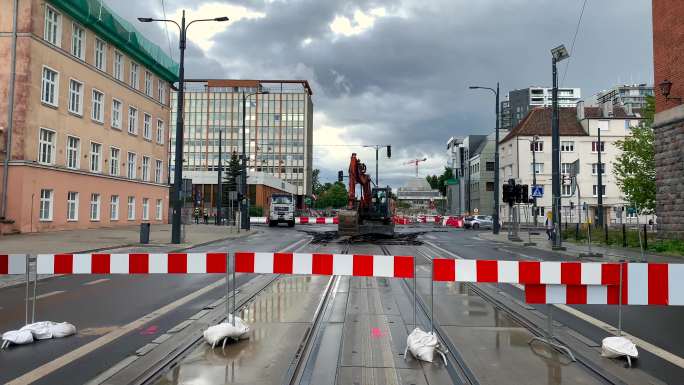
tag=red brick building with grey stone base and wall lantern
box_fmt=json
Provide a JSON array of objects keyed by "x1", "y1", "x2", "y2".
[{"x1": 652, "y1": 0, "x2": 684, "y2": 239}]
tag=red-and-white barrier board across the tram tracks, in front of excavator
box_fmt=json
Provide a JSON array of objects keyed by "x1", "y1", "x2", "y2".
[{"x1": 235, "y1": 252, "x2": 413, "y2": 278}]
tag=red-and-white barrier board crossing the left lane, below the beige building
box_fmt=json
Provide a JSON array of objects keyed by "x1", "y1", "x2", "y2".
[{"x1": 37, "y1": 253, "x2": 228, "y2": 274}]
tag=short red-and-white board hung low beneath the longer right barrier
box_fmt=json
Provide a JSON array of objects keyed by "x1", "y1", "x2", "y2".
[{"x1": 525, "y1": 285, "x2": 620, "y2": 305}]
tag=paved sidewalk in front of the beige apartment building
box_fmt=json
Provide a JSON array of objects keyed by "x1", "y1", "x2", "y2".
[{"x1": 0, "y1": 224, "x2": 249, "y2": 255}]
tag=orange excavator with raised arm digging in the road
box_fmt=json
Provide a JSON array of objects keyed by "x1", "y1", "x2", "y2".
[{"x1": 337, "y1": 153, "x2": 394, "y2": 236}]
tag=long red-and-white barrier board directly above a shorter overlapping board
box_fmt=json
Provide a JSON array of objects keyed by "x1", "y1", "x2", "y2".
[{"x1": 432, "y1": 258, "x2": 620, "y2": 285}]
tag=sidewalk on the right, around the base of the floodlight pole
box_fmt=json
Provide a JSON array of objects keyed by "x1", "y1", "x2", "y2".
[{"x1": 479, "y1": 229, "x2": 684, "y2": 263}]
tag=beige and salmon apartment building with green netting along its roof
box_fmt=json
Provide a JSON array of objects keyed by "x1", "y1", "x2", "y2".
[{"x1": 0, "y1": 0, "x2": 178, "y2": 233}]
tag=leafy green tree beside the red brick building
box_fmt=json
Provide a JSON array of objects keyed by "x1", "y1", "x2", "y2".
[{"x1": 613, "y1": 96, "x2": 656, "y2": 213}]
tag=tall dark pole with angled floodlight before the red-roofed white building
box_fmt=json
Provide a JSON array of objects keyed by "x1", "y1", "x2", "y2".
[{"x1": 551, "y1": 44, "x2": 570, "y2": 249}]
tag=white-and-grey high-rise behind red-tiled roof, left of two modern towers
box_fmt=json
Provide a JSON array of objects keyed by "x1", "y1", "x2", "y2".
[{"x1": 501, "y1": 87, "x2": 581, "y2": 130}]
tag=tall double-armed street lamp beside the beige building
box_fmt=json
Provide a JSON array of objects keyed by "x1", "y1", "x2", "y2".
[{"x1": 138, "y1": 14, "x2": 228, "y2": 244}]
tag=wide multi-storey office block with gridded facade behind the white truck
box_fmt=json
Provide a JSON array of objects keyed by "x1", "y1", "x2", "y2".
[{"x1": 169, "y1": 79, "x2": 313, "y2": 207}]
